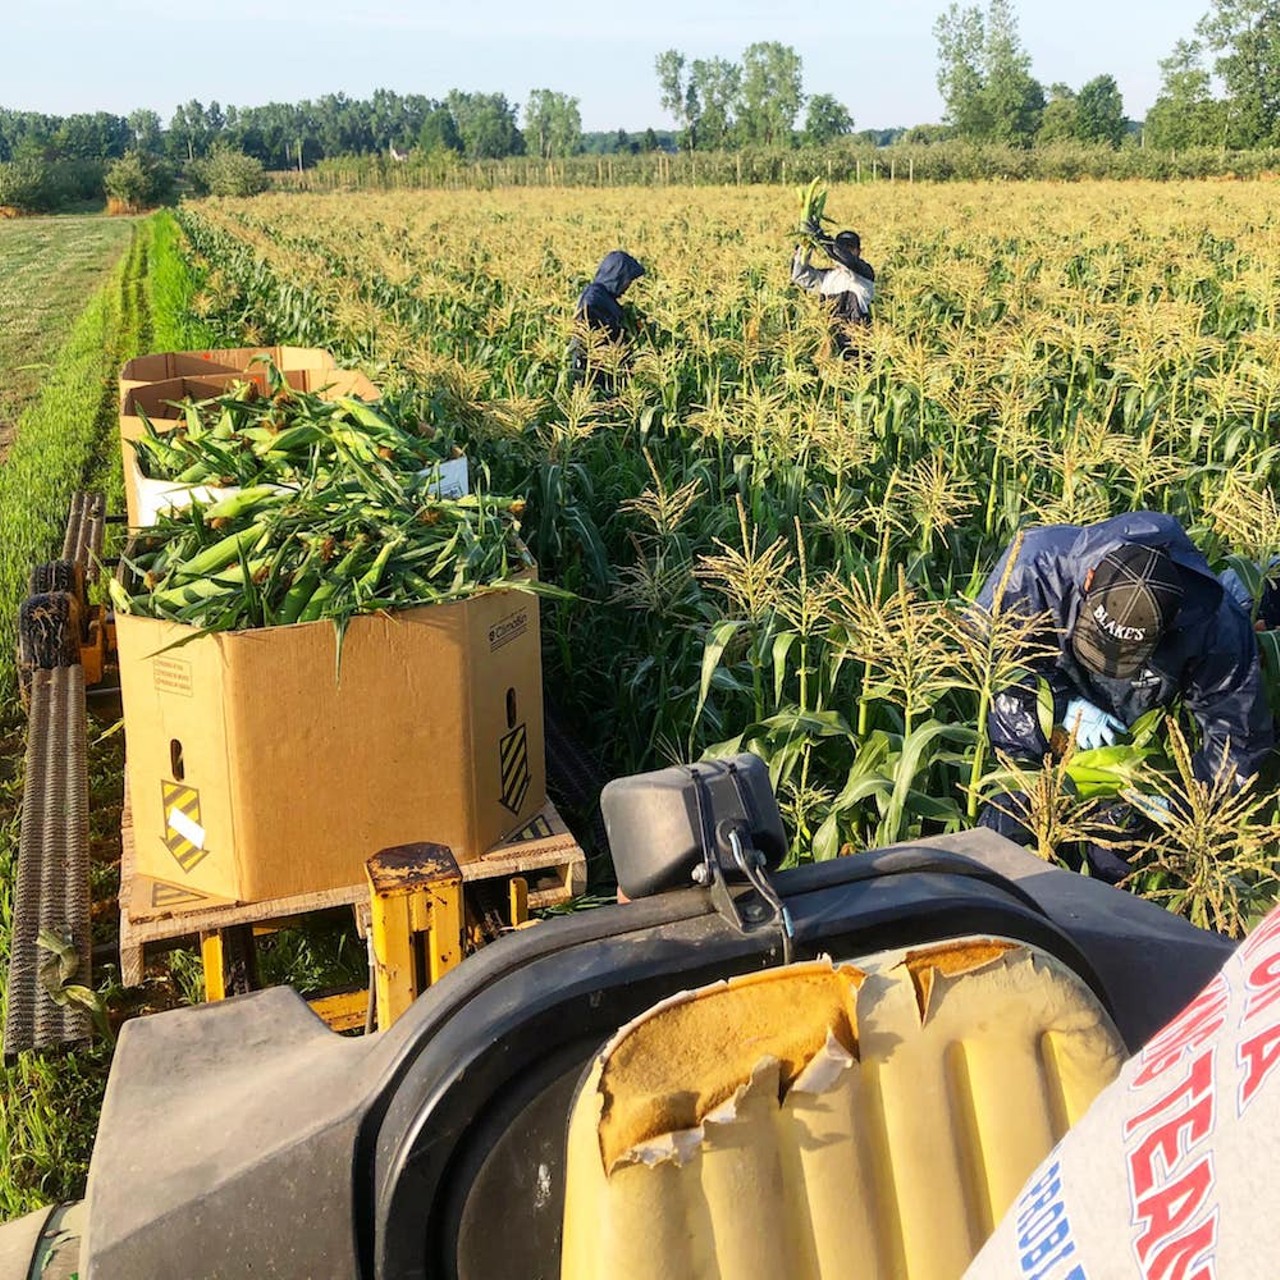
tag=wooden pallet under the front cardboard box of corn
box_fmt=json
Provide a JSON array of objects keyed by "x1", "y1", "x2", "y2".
[{"x1": 120, "y1": 794, "x2": 586, "y2": 987}]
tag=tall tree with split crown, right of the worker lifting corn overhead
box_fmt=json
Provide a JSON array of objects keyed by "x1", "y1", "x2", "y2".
[{"x1": 933, "y1": 0, "x2": 1044, "y2": 146}]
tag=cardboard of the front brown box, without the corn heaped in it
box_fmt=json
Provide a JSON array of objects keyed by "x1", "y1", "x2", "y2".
[{"x1": 115, "y1": 590, "x2": 547, "y2": 901}]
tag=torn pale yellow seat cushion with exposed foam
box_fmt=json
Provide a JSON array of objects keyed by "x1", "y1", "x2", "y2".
[{"x1": 561, "y1": 938, "x2": 1124, "y2": 1280}]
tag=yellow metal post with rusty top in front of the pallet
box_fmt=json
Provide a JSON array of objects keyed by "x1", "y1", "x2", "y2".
[{"x1": 365, "y1": 844, "x2": 462, "y2": 1030}]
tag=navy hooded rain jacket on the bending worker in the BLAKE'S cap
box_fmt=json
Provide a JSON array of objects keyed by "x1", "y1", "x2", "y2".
[{"x1": 978, "y1": 511, "x2": 1274, "y2": 785}]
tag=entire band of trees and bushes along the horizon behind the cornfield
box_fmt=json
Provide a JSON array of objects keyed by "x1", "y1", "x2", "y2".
[{"x1": 12, "y1": 0, "x2": 1280, "y2": 211}]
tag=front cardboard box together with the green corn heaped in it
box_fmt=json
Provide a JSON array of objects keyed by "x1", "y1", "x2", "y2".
[{"x1": 110, "y1": 468, "x2": 547, "y2": 901}]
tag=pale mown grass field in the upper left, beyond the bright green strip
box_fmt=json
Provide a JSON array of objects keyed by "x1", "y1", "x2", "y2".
[{"x1": 0, "y1": 216, "x2": 132, "y2": 457}]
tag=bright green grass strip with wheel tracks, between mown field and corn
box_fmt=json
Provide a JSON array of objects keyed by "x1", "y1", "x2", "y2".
[{"x1": 0, "y1": 220, "x2": 152, "y2": 1219}]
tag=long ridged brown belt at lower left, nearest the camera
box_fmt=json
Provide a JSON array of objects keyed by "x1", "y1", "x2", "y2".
[{"x1": 4, "y1": 666, "x2": 91, "y2": 1061}]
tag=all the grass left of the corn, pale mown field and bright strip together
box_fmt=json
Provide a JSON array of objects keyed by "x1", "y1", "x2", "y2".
[{"x1": 0, "y1": 216, "x2": 150, "y2": 1219}]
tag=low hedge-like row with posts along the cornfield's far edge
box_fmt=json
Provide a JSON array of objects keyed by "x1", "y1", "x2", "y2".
[{"x1": 285, "y1": 138, "x2": 1280, "y2": 192}]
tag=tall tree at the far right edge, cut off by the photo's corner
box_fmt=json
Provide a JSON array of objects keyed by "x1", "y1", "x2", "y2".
[{"x1": 1197, "y1": 0, "x2": 1280, "y2": 147}]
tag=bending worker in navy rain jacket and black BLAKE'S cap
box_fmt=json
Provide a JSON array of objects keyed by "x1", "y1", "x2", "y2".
[{"x1": 978, "y1": 511, "x2": 1274, "y2": 882}]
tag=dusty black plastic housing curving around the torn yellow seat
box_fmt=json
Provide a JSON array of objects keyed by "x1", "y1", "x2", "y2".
[{"x1": 74, "y1": 831, "x2": 1231, "y2": 1280}]
